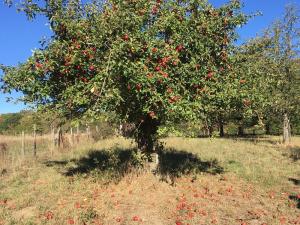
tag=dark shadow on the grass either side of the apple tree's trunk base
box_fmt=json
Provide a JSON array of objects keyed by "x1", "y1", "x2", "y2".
[{"x1": 45, "y1": 148, "x2": 224, "y2": 183}]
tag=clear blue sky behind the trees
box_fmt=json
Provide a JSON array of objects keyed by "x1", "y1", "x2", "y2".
[{"x1": 0, "y1": 0, "x2": 299, "y2": 114}]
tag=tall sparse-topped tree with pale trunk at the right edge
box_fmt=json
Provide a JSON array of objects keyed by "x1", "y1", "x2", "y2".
[{"x1": 269, "y1": 5, "x2": 300, "y2": 143}]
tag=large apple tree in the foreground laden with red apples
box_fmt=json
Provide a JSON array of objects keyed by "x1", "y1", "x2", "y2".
[{"x1": 2, "y1": 0, "x2": 247, "y2": 153}]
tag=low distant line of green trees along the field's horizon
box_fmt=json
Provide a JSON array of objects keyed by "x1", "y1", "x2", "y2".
[{"x1": 0, "y1": 111, "x2": 300, "y2": 137}]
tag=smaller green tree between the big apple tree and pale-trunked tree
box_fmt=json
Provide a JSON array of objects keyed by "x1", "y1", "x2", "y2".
[{"x1": 230, "y1": 35, "x2": 276, "y2": 135}]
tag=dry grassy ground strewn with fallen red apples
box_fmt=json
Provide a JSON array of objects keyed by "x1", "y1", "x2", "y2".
[{"x1": 0, "y1": 137, "x2": 300, "y2": 225}]
